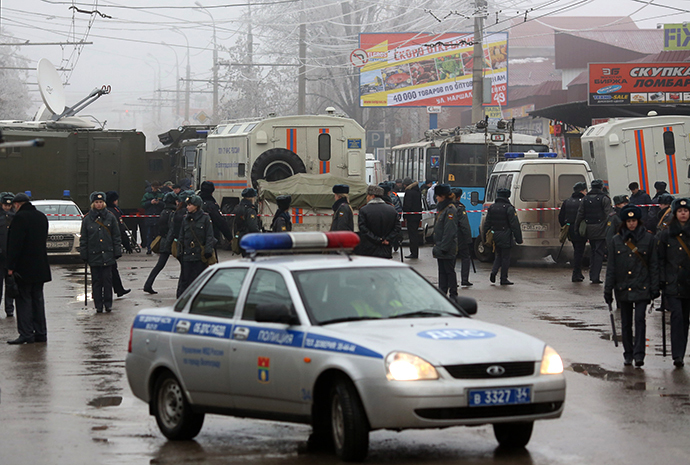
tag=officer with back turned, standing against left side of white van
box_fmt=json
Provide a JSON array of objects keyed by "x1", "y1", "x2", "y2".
[{"x1": 482, "y1": 188, "x2": 522, "y2": 286}]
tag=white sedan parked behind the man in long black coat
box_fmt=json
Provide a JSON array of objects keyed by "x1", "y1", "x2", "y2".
[{"x1": 31, "y1": 200, "x2": 83, "y2": 256}]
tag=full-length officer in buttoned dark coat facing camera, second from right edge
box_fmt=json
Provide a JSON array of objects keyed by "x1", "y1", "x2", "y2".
[{"x1": 604, "y1": 205, "x2": 659, "y2": 367}]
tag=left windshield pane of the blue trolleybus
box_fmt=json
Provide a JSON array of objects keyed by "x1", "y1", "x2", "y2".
[{"x1": 445, "y1": 144, "x2": 487, "y2": 187}]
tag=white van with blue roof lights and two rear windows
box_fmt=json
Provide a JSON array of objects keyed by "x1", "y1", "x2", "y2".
[{"x1": 475, "y1": 152, "x2": 593, "y2": 261}]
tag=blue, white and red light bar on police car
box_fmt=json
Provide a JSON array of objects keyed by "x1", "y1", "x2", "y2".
[{"x1": 240, "y1": 231, "x2": 359, "y2": 252}]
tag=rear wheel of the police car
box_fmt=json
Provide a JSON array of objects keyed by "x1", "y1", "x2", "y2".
[{"x1": 151, "y1": 372, "x2": 204, "y2": 441}]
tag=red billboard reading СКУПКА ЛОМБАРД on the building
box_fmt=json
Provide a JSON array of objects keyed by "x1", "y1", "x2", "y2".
[{"x1": 588, "y1": 63, "x2": 690, "y2": 106}]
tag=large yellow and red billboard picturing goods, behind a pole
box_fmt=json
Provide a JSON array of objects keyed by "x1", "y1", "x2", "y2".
[{"x1": 359, "y1": 32, "x2": 508, "y2": 107}]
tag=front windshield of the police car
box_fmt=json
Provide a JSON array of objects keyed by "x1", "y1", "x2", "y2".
[{"x1": 294, "y1": 267, "x2": 463, "y2": 324}]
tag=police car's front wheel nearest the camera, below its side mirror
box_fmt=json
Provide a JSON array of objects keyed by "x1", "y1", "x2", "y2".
[{"x1": 330, "y1": 380, "x2": 369, "y2": 462}]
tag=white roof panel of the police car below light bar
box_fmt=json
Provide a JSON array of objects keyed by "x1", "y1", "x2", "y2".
[{"x1": 219, "y1": 254, "x2": 408, "y2": 271}]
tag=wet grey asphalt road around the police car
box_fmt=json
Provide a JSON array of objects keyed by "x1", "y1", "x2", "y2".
[{"x1": 0, "y1": 247, "x2": 690, "y2": 465}]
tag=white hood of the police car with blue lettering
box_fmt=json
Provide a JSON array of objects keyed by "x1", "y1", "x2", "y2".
[{"x1": 323, "y1": 317, "x2": 545, "y2": 366}]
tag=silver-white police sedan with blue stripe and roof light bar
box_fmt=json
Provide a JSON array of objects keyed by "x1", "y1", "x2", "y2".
[{"x1": 126, "y1": 232, "x2": 565, "y2": 461}]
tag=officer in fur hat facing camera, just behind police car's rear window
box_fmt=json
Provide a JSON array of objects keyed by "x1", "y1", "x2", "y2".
[{"x1": 178, "y1": 195, "x2": 216, "y2": 292}]
